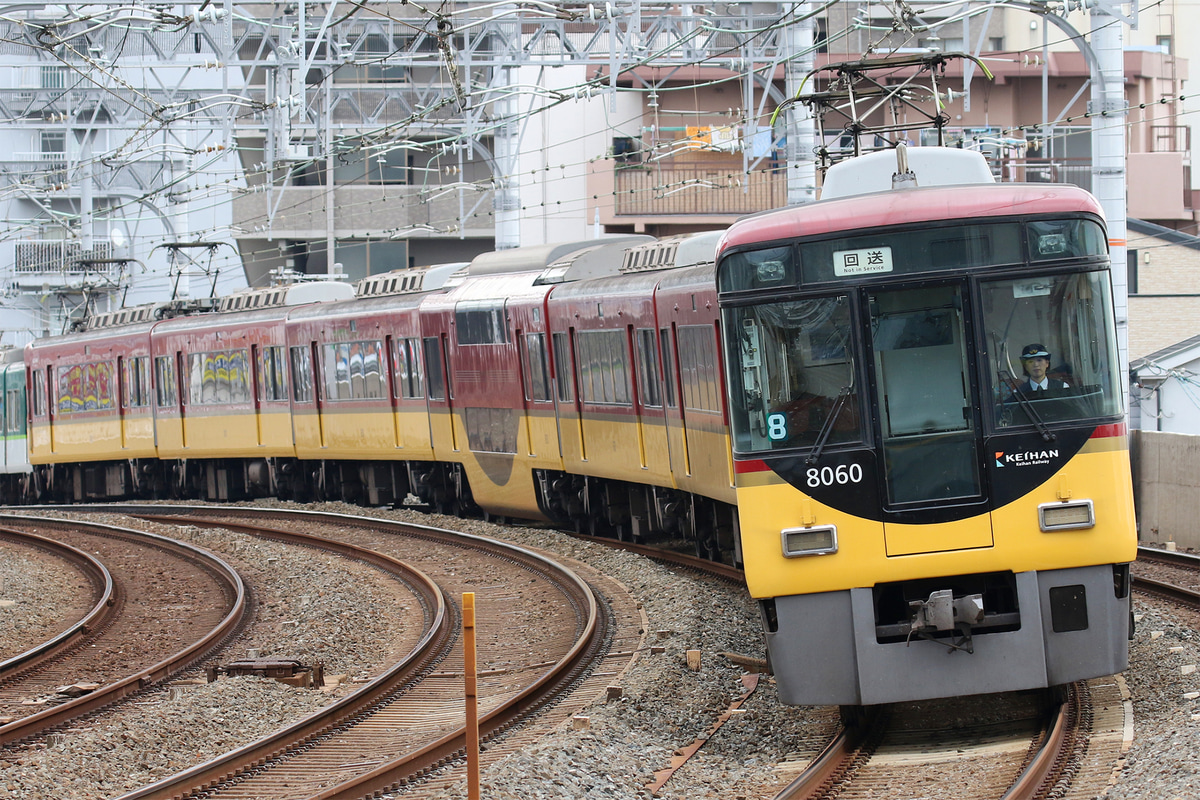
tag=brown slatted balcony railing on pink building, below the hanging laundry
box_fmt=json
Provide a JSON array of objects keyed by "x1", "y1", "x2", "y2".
[{"x1": 614, "y1": 164, "x2": 787, "y2": 216}]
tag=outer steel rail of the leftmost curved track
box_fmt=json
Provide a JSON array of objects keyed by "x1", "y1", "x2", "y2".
[{"x1": 0, "y1": 515, "x2": 247, "y2": 746}]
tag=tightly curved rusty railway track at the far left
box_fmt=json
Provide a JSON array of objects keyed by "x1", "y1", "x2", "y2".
[{"x1": 0, "y1": 516, "x2": 245, "y2": 746}]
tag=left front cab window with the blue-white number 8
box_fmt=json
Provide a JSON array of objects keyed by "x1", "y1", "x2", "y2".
[{"x1": 724, "y1": 295, "x2": 863, "y2": 453}]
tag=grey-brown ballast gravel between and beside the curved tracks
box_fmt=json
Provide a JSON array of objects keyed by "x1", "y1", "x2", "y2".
[{"x1": 0, "y1": 501, "x2": 1200, "y2": 800}]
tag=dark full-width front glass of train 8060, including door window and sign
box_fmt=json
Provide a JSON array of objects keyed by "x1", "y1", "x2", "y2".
[{"x1": 719, "y1": 219, "x2": 1122, "y2": 506}]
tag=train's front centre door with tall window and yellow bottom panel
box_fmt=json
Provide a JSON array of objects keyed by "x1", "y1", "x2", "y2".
[{"x1": 864, "y1": 283, "x2": 992, "y2": 555}]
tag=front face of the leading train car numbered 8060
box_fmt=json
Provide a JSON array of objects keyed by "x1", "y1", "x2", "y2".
[{"x1": 718, "y1": 149, "x2": 1136, "y2": 705}]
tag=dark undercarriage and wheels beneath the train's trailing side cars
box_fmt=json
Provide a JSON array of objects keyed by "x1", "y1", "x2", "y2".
[{"x1": 23, "y1": 458, "x2": 742, "y2": 564}]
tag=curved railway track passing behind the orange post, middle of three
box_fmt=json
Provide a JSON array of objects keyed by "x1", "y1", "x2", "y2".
[{"x1": 16, "y1": 507, "x2": 619, "y2": 800}]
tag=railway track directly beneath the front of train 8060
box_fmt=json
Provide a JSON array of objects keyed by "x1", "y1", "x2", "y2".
[{"x1": 775, "y1": 681, "x2": 1124, "y2": 800}]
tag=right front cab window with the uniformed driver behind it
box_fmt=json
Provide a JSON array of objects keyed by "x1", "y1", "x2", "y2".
[{"x1": 982, "y1": 272, "x2": 1123, "y2": 429}]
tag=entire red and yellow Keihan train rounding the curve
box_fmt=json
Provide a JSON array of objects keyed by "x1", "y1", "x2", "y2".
[{"x1": 16, "y1": 148, "x2": 1136, "y2": 705}]
